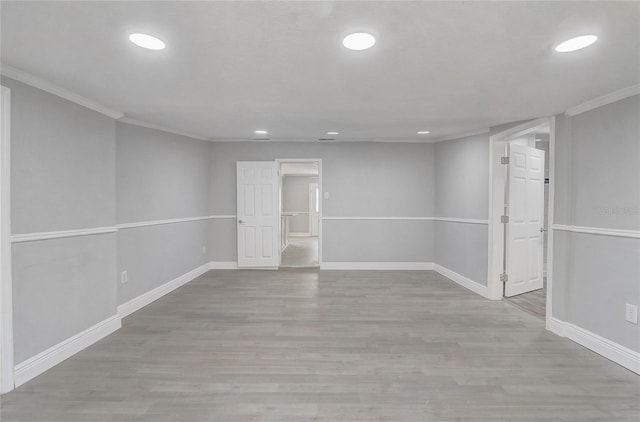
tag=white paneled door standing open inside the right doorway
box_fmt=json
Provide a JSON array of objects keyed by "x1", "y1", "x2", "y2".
[{"x1": 505, "y1": 144, "x2": 544, "y2": 297}]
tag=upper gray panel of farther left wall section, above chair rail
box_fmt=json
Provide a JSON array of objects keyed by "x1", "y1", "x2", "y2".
[{"x1": 116, "y1": 123, "x2": 211, "y2": 223}]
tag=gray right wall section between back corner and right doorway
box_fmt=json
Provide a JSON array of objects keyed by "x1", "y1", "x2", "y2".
[{"x1": 435, "y1": 134, "x2": 489, "y2": 286}]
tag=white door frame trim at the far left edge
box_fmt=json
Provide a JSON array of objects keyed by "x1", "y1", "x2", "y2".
[{"x1": 0, "y1": 86, "x2": 15, "y2": 394}]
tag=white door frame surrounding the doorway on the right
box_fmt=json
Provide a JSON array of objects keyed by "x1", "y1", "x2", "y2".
[{"x1": 487, "y1": 116, "x2": 556, "y2": 316}]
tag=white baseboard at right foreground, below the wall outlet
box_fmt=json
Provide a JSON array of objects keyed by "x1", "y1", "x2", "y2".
[{"x1": 547, "y1": 317, "x2": 640, "y2": 374}]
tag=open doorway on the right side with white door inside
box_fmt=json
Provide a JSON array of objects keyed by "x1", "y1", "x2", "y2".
[{"x1": 489, "y1": 119, "x2": 554, "y2": 318}]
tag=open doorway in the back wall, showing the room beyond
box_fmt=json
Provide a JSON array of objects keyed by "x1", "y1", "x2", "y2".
[{"x1": 278, "y1": 159, "x2": 322, "y2": 268}]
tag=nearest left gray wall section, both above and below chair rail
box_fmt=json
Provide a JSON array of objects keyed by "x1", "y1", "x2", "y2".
[{"x1": 2, "y1": 78, "x2": 117, "y2": 363}]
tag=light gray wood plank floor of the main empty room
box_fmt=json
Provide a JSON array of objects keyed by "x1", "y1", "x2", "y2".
[{"x1": 1, "y1": 270, "x2": 640, "y2": 422}]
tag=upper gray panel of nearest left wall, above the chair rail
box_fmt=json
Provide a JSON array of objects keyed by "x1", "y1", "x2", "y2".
[{"x1": 2, "y1": 77, "x2": 115, "y2": 234}]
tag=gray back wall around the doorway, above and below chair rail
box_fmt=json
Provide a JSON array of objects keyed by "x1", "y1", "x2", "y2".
[{"x1": 211, "y1": 142, "x2": 435, "y2": 262}]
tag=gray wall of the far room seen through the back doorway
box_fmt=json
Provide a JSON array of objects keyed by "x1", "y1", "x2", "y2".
[{"x1": 282, "y1": 176, "x2": 318, "y2": 233}]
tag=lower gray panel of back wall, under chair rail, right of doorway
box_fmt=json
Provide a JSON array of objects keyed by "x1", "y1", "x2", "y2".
[{"x1": 322, "y1": 220, "x2": 434, "y2": 262}]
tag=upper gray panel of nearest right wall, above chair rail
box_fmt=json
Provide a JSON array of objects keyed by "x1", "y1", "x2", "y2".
[{"x1": 571, "y1": 95, "x2": 640, "y2": 230}]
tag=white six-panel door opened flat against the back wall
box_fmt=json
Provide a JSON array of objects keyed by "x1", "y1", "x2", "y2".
[{"x1": 236, "y1": 161, "x2": 280, "y2": 268}]
